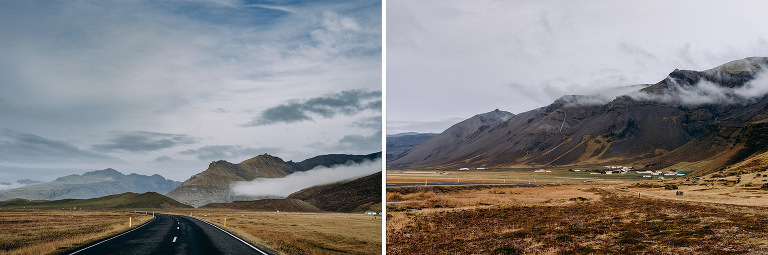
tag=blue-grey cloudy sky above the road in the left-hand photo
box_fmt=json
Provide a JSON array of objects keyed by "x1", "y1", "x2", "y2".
[{"x1": 0, "y1": 0, "x2": 382, "y2": 182}]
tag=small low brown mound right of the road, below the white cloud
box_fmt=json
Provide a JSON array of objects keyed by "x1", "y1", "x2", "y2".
[{"x1": 201, "y1": 199, "x2": 323, "y2": 212}]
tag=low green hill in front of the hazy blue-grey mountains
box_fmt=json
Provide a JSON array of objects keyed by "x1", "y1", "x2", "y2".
[{"x1": 0, "y1": 192, "x2": 191, "y2": 209}]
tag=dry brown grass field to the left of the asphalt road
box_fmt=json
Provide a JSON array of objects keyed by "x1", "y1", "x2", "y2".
[{"x1": 0, "y1": 210, "x2": 152, "y2": 255}]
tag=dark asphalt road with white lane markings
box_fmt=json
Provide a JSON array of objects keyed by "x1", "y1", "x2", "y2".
[{"x1": 71, "y1": 214, "x2": 268, "y2": 255}]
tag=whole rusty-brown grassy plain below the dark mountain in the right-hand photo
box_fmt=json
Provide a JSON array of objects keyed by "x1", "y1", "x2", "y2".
[{"x1": 386, "y1": 170, "x2": 768, "y2": 254}]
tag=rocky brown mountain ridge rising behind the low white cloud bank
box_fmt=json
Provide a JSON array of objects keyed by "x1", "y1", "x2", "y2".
[{"x1": 167, "y1": 152, "x2": 381, "y2": 207}]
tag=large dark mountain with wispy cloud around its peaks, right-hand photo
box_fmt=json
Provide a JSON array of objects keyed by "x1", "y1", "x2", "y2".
[{"x1": 388, "y1": 58, "x2": 768, "y2": 174}]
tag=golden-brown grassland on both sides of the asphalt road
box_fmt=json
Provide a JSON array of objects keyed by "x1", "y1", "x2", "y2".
[{"x1": 0, "y1": 209, "x2": 382, "y2": 254}]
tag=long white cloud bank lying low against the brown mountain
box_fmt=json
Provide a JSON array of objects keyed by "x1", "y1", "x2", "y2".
[{"x1": 231, "y1": 159, "x2": 381, "y2": 197}]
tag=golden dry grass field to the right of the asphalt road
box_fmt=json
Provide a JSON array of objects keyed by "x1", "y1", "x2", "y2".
[{"x1": 161, "y1": 209, "x2": 382, "y2": 254}]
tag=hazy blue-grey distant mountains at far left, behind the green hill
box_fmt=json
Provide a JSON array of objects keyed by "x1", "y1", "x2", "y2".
[{"x1": 0, "y1": 168, "x2": 181, "y2": 200}]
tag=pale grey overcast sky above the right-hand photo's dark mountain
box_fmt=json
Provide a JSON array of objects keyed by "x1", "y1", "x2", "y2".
[{"x1": 386, "y1": 0, "x2": 768, "y2": 134}]
